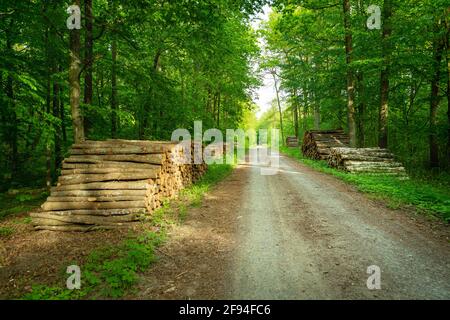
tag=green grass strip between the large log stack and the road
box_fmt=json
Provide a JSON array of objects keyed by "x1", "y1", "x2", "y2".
[{"x1": 22, "y1": 165, "x2": 233, "y2": 300}]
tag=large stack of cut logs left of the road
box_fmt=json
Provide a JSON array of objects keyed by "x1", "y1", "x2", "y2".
[{"x1": 31, "y1": 140, "x2": 206, "y2": 231}]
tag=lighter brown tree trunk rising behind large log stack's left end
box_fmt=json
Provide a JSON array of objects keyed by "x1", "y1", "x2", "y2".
[{"x1": 69, "y1": 0, "x2": 85, "y2": 143}]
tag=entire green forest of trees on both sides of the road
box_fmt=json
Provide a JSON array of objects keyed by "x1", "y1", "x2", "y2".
[{"x1": 0, "y1": 0, "x2": 450, "y2": 190}]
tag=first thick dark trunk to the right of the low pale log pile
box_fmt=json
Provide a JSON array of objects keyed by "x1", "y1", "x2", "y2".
[{"x1": 429, "y1": 23, "x2": 444, "y2": 168}]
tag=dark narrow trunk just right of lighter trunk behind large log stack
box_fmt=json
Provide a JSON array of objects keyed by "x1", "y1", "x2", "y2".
[{"x1": 83, "y1": 0, "x2": 94, "y2": 132}]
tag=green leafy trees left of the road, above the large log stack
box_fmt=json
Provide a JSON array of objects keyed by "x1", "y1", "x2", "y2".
[{"x1": 0, "y1": 0, "x2": 261, "y2": 189}]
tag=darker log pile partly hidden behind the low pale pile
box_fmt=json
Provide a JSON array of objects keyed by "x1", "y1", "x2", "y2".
[{"x1": 302, "y1": 129, "x2": 350, "y2": 160}]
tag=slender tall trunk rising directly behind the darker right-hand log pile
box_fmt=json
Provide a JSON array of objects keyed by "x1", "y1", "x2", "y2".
[{"x1": 343, "y1": 0, "x2": 356, "y2": 147}]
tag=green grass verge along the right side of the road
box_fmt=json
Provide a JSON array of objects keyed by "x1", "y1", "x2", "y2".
[{"x1": 280, "y1": 146, "x2": 450, "y2": 222}]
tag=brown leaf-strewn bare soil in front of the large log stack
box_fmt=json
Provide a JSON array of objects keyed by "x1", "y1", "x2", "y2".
[{"x1": 0, "y1": 213, "x2": 133, "y2": 299}]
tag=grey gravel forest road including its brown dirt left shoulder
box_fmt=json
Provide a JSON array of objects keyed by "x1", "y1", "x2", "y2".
[{"x1": 134, "y1": 157, "x2": 450, "y2": 299}]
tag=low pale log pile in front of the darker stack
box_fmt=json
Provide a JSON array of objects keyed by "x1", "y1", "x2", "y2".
[{"x1": 328, "y1": 148, "x2": 406, "y2": 176}]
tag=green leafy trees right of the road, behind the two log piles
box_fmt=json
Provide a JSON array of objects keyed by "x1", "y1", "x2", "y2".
[{"x1": 263, "y1": 0, "x2": 450, "y2": 172}]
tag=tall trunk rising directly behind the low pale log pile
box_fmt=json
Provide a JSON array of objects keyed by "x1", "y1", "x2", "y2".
[{"x1": 378, "y1": 0, "x2": 392, "y2": 148}]
